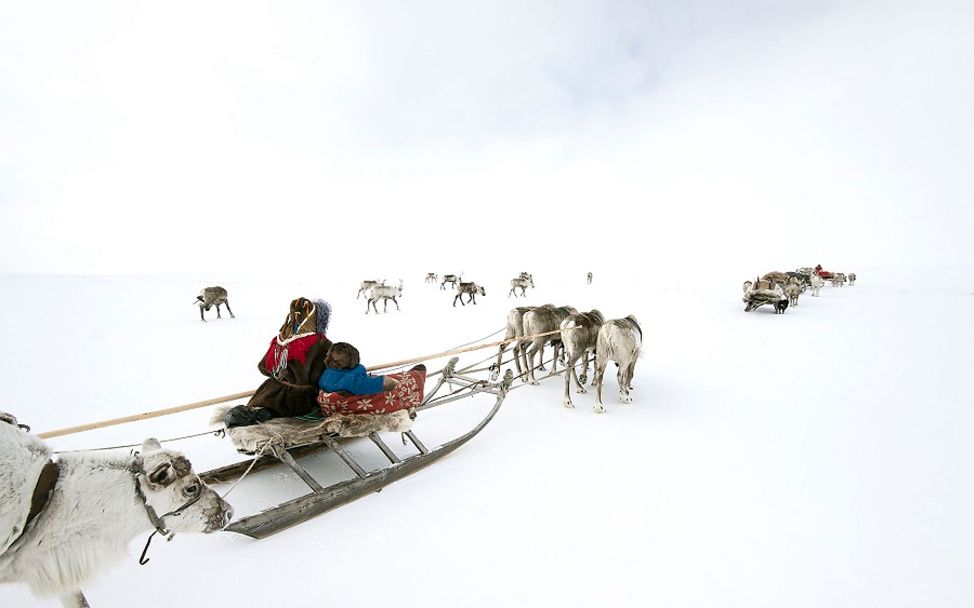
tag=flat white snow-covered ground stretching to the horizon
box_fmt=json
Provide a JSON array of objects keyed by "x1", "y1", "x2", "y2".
[{"x1": 0, "y1": 268, "x2": 974, "y2": 608}]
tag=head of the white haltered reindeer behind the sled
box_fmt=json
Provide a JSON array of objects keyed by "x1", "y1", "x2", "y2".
[{"x1": 132, "y1": 438, "x2": 233, "y2": 533}]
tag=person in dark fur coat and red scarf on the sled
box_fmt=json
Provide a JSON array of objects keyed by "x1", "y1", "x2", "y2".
[{"x1": 223, "y1": 298, "x2": 331, "y2": 427}]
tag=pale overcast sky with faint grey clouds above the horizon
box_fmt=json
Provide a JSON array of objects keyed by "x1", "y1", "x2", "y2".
[{"x1": 0, "y1": 0, "x2": 974, "y2": 276}]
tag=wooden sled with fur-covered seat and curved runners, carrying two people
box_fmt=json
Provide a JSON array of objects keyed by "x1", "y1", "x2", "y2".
[{"x1": 200, "y1": 357, "x2": 513, "y2": 539}]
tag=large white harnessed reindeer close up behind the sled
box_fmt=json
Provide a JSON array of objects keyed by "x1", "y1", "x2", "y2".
[{"x1": 0, "y1": 413, "x2": 233, "y2": 608}]
